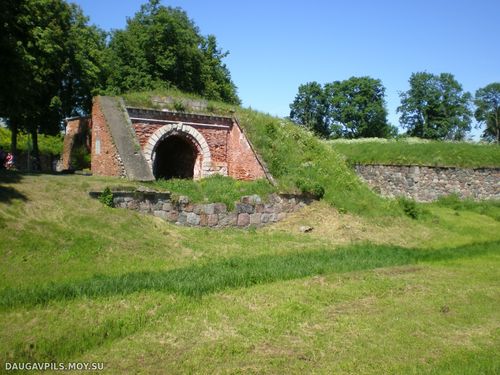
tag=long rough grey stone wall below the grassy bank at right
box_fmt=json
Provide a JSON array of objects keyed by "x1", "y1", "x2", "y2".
[{"x1": 355, "y1": 165, "x2": 500, "y2": 202}]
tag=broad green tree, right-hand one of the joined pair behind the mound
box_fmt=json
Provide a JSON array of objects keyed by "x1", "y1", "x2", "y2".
[{"x1": 325, "y1": 77, "x2": 397, "y2": 138}]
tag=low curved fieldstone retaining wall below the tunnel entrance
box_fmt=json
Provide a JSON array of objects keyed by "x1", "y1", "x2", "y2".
[{"x1": 89, "y1": 190, "x2": 313, "y2": 228}]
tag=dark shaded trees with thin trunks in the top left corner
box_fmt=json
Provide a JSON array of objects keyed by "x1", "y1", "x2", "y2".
[{"x1": 0, "y1": 0, "x2": 104, "y2": 165}]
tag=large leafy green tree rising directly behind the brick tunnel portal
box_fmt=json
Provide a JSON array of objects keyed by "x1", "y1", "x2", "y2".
[{"x1": 108, "y1": 0, "x2": 239, "y2": 103}]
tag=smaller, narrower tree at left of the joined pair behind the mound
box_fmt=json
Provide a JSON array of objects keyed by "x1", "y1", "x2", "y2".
[{"x1": 290, "y1": 82, "x2": 330, "y2": 138}]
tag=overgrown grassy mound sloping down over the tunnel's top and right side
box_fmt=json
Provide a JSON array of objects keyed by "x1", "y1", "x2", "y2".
[{"x1": 124, "y1": 91, "x2": 400, "y2": 215}]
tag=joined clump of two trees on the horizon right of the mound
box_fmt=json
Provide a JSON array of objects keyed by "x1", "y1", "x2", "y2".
[{"x1": 290, "y1": 77, "x2": 397, "y2": 138}]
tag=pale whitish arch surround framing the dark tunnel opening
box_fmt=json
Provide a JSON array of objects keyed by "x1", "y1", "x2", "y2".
[{"x1": 144, "y1": 123, "x2": 212, "y2": 179}]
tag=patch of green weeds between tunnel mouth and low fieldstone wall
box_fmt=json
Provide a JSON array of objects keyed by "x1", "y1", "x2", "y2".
[{"x1": 151, "y1": 175, "x2": 276, "y2": 210}]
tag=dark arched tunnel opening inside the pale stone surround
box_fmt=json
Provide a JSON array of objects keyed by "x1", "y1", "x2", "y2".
[{"x1": 153, "y1": 135, "x2": 198, "y2": 179}]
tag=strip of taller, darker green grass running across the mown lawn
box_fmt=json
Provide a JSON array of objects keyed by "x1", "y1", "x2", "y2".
[{"x1": 0, "y1": 241, "x2": 500, "y2": 309}]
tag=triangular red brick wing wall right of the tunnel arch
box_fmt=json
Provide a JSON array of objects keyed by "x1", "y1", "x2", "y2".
[{"x1": 227, "y1": 123, "x2": 266, "y2": 180}]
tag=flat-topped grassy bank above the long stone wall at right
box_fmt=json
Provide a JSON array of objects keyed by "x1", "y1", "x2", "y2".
[{"x1": 327, "y1": 138, "x2": 500, "y2": 168}]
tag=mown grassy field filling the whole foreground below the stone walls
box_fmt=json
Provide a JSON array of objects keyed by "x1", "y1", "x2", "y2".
[{"x1": 0, "y1": 173, "x2": 500, "y2": 374}]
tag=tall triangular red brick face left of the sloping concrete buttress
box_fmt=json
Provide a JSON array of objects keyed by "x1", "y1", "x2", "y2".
[{"x1": 91, "y1": 97, "x2": 125, "y2": 176}]
